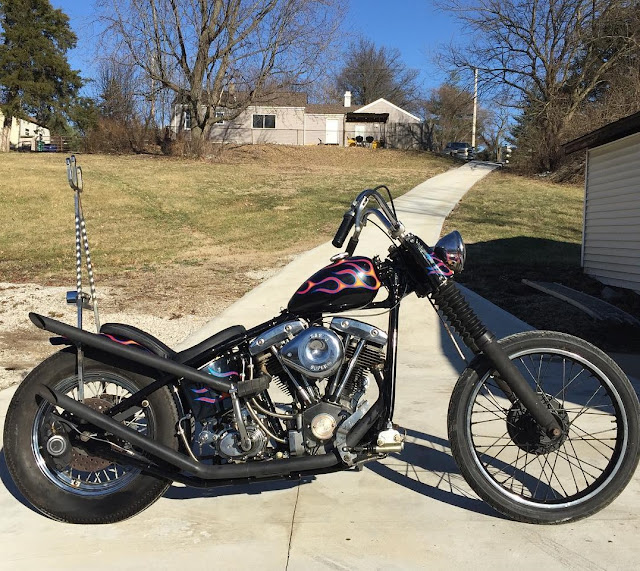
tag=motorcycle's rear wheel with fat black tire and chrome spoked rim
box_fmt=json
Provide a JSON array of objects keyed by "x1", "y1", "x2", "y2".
[{"x1": 4, "y1": 349, "x2": 178, "y2": 524}]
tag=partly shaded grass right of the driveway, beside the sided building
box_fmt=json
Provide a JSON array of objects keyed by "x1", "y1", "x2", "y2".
[{"x1": 443, "y1": 171, "x2": 640, "y2": 351}]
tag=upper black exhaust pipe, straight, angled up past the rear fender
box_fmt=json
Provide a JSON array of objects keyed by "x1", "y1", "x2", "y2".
[{"x1": 29, "y1": 313, "x2": 231, "y2": 393}]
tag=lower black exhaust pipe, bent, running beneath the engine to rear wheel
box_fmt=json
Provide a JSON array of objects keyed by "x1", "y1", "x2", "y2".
[{"x1": 36, "y1": 385, "x2": 340, "y2": 480}]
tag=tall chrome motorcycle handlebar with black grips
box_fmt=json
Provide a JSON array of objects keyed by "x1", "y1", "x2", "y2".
[{"x1": 332, "y1": 188, "x2": 404, "y2": 255}]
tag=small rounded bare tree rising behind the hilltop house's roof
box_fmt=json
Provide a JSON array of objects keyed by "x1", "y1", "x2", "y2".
[{"x1": 336, "y1": 38, "x2": 418, "y2": 108}]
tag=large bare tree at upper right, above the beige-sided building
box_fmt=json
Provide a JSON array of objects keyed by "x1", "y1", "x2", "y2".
[{"x1": 444, "y1": 0, "x2": 639, "y2": 169}]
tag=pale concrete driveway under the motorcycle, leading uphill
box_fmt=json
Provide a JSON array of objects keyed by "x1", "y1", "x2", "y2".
[{"x1": 0, "y1": 165, "x2": 640, "y2": 571}]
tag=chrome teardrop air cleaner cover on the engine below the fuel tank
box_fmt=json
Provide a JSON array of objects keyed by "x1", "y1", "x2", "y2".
[{"x1": 280, "y1": 327, "x2": 344, "y2": 379}]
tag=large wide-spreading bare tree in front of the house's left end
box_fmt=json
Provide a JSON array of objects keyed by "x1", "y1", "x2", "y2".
[{"x1": 101, "y1": 0, "x2": 337, "y2": 152}]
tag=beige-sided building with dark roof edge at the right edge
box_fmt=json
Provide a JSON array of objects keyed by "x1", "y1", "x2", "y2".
[{"x1": 563, "y1": 112, "x2": 640, "y2": 293}]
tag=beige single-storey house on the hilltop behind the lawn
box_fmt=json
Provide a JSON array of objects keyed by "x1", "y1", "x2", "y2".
[{"x1": 171, "y1": 91, "x2": 422, "y2": 148}]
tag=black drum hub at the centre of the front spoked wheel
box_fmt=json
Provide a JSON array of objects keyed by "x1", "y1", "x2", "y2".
[{"x1": 507, "y1": 395, "x2": 569, "y2": 455}]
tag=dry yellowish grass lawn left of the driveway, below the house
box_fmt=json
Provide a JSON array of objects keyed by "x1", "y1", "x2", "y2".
[{"x1": 0, "y1": 146, "x2": 450, "y2": 283}]
